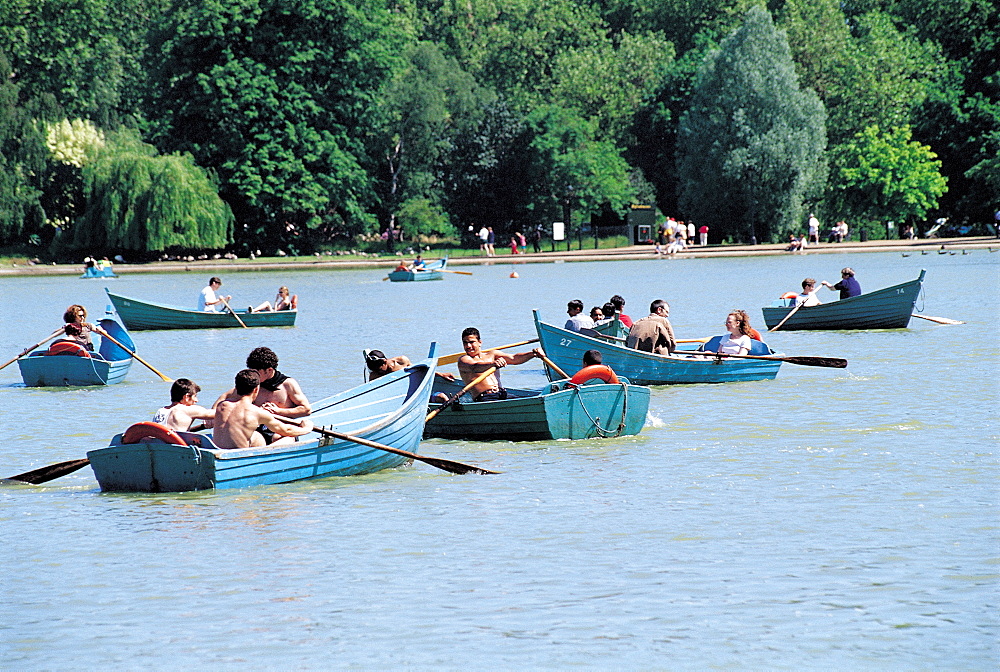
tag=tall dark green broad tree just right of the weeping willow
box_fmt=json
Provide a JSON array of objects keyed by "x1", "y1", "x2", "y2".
[{"x1": 148, "y1": 0, "x2": 402, "y2": 249}]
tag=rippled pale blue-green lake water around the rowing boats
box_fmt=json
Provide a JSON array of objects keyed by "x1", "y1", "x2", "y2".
[{"x1": 0, "y1": 250, "x2": 1000, "y2": 670}]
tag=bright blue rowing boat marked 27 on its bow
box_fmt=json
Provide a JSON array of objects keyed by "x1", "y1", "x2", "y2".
[{"x1": 533, "y1": 310, "x2": 781, "y2": 385}]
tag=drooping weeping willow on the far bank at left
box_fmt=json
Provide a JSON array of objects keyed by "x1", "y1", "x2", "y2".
[{"x1": 73, "y1": 136, "x2": 233, "y2": 253}]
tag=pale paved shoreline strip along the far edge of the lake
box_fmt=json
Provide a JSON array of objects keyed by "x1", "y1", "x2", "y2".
[{"x1": 0, "y1": 236, "x2": 1000, "y2": 279}]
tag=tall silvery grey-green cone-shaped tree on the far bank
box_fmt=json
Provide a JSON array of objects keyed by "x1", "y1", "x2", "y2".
[{"x1": 678, "y1": 7, "x2": 826, "y2": 240}]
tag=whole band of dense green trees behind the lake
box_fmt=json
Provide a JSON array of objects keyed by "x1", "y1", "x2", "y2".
[{"x1": 0, "y1": 0, "x2": 1000, "y2": 253}]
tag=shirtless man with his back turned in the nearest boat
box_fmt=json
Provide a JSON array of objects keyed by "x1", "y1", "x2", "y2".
[{"x1": 212, "y1": 369, "x2": 313, "y2": 448}]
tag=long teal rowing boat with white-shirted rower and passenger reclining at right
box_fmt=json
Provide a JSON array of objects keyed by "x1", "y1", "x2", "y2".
[{"x1": 104, "y1": 287, "x2": 298, "y2": 331}]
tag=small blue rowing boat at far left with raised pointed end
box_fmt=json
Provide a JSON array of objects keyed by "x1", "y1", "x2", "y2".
[{"x1": 17, "y1": 314, "x2": 135, "y2": 387}]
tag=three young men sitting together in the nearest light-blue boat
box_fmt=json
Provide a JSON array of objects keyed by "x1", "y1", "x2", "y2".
[{"x1": 152, "y1": 346, "x2": 313, "y2": 448}]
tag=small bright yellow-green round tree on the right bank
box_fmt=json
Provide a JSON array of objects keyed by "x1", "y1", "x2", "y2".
[{"x1": 832, "y1": 126, "x2": 948, "y2": 234}]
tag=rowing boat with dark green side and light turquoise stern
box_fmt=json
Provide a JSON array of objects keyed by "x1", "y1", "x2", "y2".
[{"x1": 424, "y1": 376, "x2": 649, "y2": 441}]
